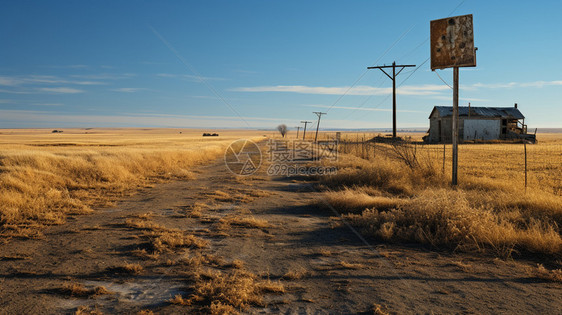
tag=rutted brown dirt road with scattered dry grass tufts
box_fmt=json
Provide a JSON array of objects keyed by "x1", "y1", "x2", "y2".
[{"x1": 0, "y1": 154, "x2": 562, "y2": 314}]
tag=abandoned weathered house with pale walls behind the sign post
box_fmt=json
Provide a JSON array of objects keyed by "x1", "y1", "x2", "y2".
[{"x1": 424, "y1": 104, "x2": 535, "y2": 143}]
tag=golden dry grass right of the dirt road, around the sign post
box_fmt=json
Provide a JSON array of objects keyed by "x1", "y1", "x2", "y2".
[{"x1": 320, "y1": 134, "x2": 562, "y2": 262}]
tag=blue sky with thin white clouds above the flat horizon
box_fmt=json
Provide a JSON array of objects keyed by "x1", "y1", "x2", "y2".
[{"x1": 0, "y1": 0, "x2": 562, "y2": 129}]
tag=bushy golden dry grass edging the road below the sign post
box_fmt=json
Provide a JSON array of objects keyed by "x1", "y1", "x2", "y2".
[{"x1": 348, "y1": 189, "x2": 562, "y2": 256}]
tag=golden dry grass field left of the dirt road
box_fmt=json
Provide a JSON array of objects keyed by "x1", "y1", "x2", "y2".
[{"x1": 0, "y1": 128, "x2": 261, "y2": 239}]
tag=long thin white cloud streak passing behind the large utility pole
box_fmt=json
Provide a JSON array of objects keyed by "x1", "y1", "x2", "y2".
[{"x1": 230, "y1": 84, "x2": 448, "y2": 95}]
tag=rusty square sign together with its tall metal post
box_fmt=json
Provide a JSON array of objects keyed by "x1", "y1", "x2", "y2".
[{"x1": 430, "y1": 14, "x2": 476, "y2": 186}]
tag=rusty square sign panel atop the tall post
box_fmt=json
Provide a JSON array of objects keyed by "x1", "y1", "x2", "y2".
[{"x1": 430, "y1": 14, "x2": 476, "y2": 70}]
